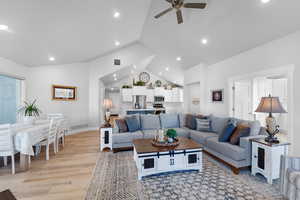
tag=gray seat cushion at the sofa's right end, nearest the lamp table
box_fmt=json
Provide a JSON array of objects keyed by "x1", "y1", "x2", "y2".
[{"x1": 206, "y1": 137, "x2": 247, "y2": 161}]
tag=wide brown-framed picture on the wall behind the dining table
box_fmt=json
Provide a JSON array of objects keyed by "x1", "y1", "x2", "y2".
[{"x1": 52, "y1": 85, "x2": 77, "y2": 101}]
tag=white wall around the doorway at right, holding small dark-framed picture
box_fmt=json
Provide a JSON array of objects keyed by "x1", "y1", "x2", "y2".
[{"x1": 185, "y1": 31, "x2": 300, "y2": 156}]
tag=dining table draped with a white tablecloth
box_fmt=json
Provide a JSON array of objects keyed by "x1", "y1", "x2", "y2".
[{"x1": 11, "y1": 120, "x2": 50, "y2": 171}]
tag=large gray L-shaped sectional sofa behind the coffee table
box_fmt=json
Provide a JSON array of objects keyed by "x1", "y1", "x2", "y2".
[{"x1": 112, "y1": 114, "x2": 262, "y2": 174}]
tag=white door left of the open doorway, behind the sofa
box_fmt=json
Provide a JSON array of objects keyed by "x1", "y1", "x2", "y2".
[{"x1": 233, "y1": 80, "x2": 254, "y2": 120}]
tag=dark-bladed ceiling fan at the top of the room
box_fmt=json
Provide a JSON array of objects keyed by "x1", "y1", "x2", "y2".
[{"x1": 154, "y1": 0, "x2": 207, "y2": 24}]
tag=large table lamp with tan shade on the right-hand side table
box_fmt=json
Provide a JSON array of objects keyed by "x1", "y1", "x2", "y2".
[{"x1": 255, "y1": 95, "x2": 286, "y2": 143}]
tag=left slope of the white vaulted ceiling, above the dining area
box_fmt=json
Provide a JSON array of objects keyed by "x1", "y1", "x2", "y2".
[{"x1": 0, "y1": 0, "x2": 151, "y2": 66}]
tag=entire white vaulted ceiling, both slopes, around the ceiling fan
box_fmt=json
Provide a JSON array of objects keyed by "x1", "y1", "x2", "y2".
[{"x1": 0, "y1": 0, "x2": 300, "y2": 76}]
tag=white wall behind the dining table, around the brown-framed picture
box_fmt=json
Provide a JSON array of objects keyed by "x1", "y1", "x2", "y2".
[{"x1": 27, "y1": 63, "x2": 89, "y2": 126}]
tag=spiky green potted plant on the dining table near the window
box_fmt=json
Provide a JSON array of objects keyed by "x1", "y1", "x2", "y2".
[{"x1": 19, "y1": 100, "x2": 41, "y2": 124}]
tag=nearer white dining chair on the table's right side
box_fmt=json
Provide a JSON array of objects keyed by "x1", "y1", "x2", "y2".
[{"x1": 39, "y1": 119, "x2": 58, "y2": 160}]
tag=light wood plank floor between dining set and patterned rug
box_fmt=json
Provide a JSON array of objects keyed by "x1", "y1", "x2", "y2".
[{"x1": 0, "y1": 131, "x2": 99, "y2": 200}]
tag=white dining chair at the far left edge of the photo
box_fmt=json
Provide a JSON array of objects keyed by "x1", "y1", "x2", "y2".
[{"x1": 0, "y1": 124, "x2": 17, "y2": 174}]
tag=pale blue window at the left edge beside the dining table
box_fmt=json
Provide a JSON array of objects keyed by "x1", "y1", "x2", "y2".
[{"x1": 0, "y1": 75, "x2": 22, "y2": 124}]
